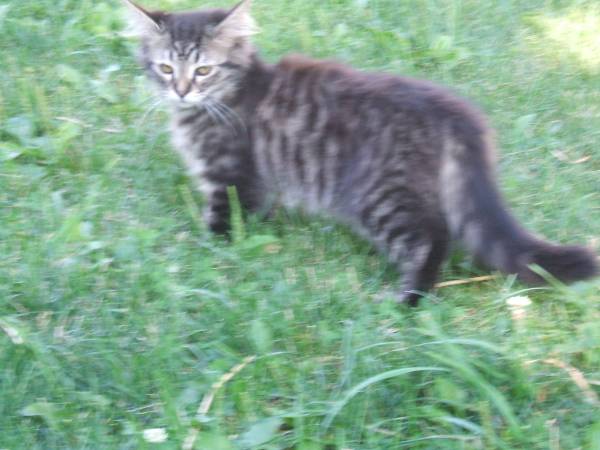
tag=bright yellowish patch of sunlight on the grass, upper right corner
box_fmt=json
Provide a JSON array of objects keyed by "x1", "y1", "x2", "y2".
[{"x1": 528, "y1": 6, "x2": 600, "y2": 72}]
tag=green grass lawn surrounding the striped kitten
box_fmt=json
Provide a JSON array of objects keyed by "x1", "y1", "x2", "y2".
[{"x1": 0, "y1": 0, "x2": 600, "y2": 450}]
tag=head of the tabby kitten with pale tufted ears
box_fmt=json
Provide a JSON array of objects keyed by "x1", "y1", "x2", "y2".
[{"x1": 123, "y1": 0, "x2": 257, "y2": 107}]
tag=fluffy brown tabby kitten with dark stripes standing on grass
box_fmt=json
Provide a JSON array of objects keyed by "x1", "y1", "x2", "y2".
[{"x1": 124, "y1": 0, "x2": 598, "y2": 305}]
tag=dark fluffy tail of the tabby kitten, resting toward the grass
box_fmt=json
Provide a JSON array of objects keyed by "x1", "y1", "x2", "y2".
[{"x1": 440, "y1": 129, "x2": 599, "y2": 284}]
